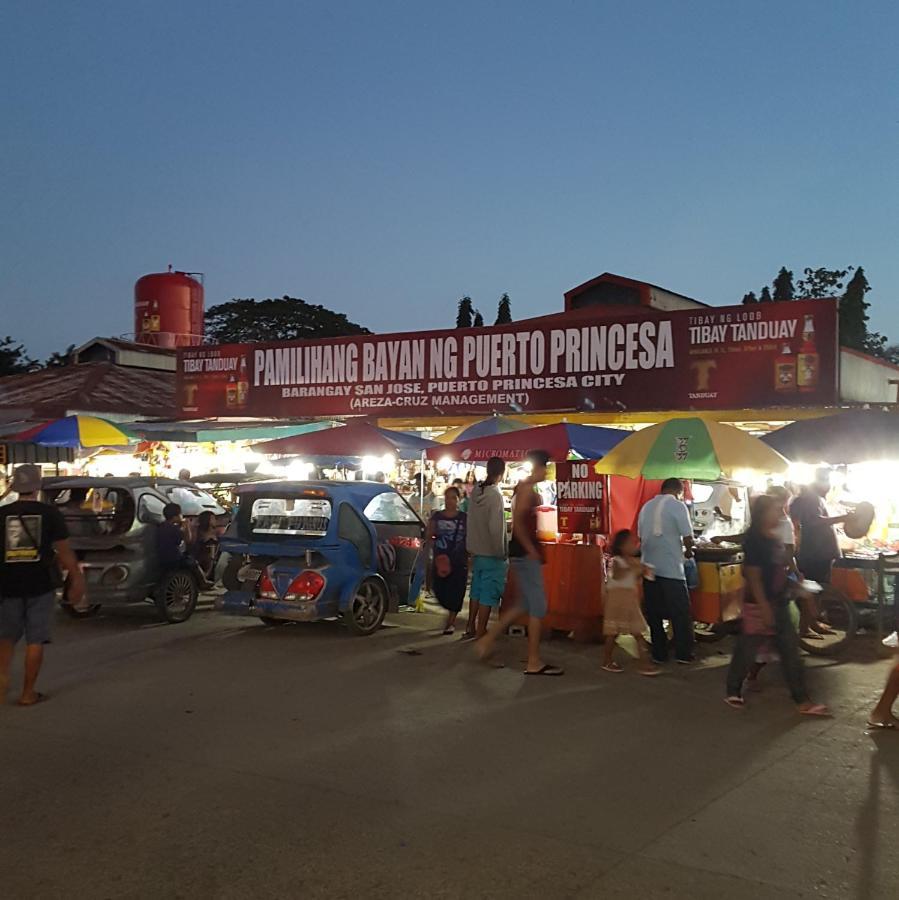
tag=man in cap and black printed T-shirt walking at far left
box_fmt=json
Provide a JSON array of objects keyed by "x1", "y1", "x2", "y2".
[{"x1": 0, "y1": 465, "x2": 87, "y2": 706}]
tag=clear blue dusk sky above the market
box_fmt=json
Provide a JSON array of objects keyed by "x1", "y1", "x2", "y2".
[{"x1": 0, "y1": 0, "x2": 899, "y2": 357}]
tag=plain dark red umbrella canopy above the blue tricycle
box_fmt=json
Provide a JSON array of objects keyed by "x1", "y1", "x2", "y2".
[{"x1": 253, "y1": 422, "x2": 436, "y2": 458}]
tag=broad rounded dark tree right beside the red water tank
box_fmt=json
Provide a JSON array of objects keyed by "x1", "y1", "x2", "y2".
[{"x1": 206, "y1": 295, "x2": 371, "y2": 344}]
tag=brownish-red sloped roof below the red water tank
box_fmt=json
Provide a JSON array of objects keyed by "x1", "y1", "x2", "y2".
[{"x1": 0, "y1": 363, "x2": 177, "y2": 418}]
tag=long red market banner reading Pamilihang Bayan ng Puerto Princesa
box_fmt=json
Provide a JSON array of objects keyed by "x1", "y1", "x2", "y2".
[{"x1": 178, "y1": 300, "x2": 838, "y2": 418}]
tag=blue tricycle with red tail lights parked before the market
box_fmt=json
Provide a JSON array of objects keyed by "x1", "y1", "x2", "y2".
[{"x1": 217, "y1": 481, "x2": 425, "y2": 635}]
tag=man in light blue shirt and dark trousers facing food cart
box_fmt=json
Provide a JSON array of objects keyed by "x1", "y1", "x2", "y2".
[{"x1": 637, "y1": 478, "x2": 693, "y2": 665}]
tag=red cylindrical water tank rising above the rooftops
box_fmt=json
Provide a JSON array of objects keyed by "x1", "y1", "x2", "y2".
[{"x1": 134, "y1": 266, "x2": 204, "y2": 347}]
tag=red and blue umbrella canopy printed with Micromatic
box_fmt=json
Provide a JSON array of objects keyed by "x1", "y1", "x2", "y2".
[{"x1": 427, "y1": 424, "x2": 628, "y2": 462}]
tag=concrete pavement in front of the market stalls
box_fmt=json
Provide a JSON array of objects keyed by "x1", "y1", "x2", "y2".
[{"x1": 0, "y1": 609, "x2": 899, "y2": 900}]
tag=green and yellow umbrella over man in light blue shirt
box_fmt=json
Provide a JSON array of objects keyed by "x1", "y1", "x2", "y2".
[{"x1": 596, "y1": 419, "x2": 789, "y2": 481}]
